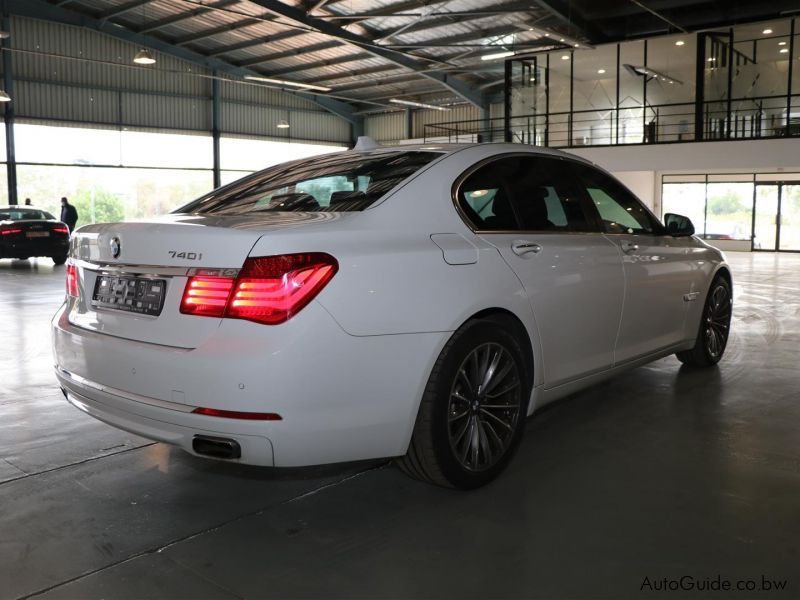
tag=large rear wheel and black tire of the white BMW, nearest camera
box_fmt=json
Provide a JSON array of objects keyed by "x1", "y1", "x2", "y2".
[{"x1": 397, "y1": 319, "x2": 533, "y2": 489}]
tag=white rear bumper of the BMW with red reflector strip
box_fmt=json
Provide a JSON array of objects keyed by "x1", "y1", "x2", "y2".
[{"x1": 52, "y1": 302, "x2": 450, "y2": 467}]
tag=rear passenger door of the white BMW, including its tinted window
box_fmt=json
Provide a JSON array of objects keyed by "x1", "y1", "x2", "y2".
[{"x1": 457, "y1": 154, "x2": 624, "y2": 388}]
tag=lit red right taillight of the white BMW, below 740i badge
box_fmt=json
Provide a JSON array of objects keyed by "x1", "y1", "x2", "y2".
[{"x1": 181, "y1": 252, "x2": 339, "y2": 325}]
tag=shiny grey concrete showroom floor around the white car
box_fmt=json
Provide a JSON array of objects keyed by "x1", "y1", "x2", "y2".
[{"x1": 0, "y1": 253, "x2": 800, "y2": 599}]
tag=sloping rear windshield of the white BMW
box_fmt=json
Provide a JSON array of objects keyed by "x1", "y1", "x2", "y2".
[{"x1": 174, "y1": 151, "x2": 441, "y2": 215}]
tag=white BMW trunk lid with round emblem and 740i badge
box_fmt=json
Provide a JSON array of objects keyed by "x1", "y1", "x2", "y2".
[{"x1": 68, "y1": 213, "x2": 344, "y2": 348}]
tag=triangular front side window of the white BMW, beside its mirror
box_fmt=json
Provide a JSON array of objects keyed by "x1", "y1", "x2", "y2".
[{"x1": 573, "y1": 164, "x2": 661, "y2": 234}]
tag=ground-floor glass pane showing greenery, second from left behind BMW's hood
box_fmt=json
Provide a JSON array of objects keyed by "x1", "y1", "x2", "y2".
[{"x1": 705, "y1": 182, "x2": 753, "y2": 240}]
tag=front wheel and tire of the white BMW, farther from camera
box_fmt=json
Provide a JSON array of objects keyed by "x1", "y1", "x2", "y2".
[{"x1": 675, "y1": 275, "x2": 733, "y2": 367}]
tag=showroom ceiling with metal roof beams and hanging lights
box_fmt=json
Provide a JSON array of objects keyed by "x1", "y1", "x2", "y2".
[{"x1": 18, "y1": 0, "x2": 800, "y2": 111}]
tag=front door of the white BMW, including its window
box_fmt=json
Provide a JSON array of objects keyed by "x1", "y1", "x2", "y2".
[{"x1": 572, "y1": 163, "x2": 702, "y2": 363}]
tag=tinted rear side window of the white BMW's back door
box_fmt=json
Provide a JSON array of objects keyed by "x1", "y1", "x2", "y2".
[{"x1": 457, "y1": 156, "x2": 591, "y2": 232}]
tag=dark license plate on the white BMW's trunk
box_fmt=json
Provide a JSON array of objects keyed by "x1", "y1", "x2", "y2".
[{"x1": 92, "y1": 275, "x2": 167, "y2": 316}]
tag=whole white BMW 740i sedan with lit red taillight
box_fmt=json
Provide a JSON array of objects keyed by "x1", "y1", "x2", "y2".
[{"x1": 52, "y1": 144, "x2": 732, "y2": 488}]
